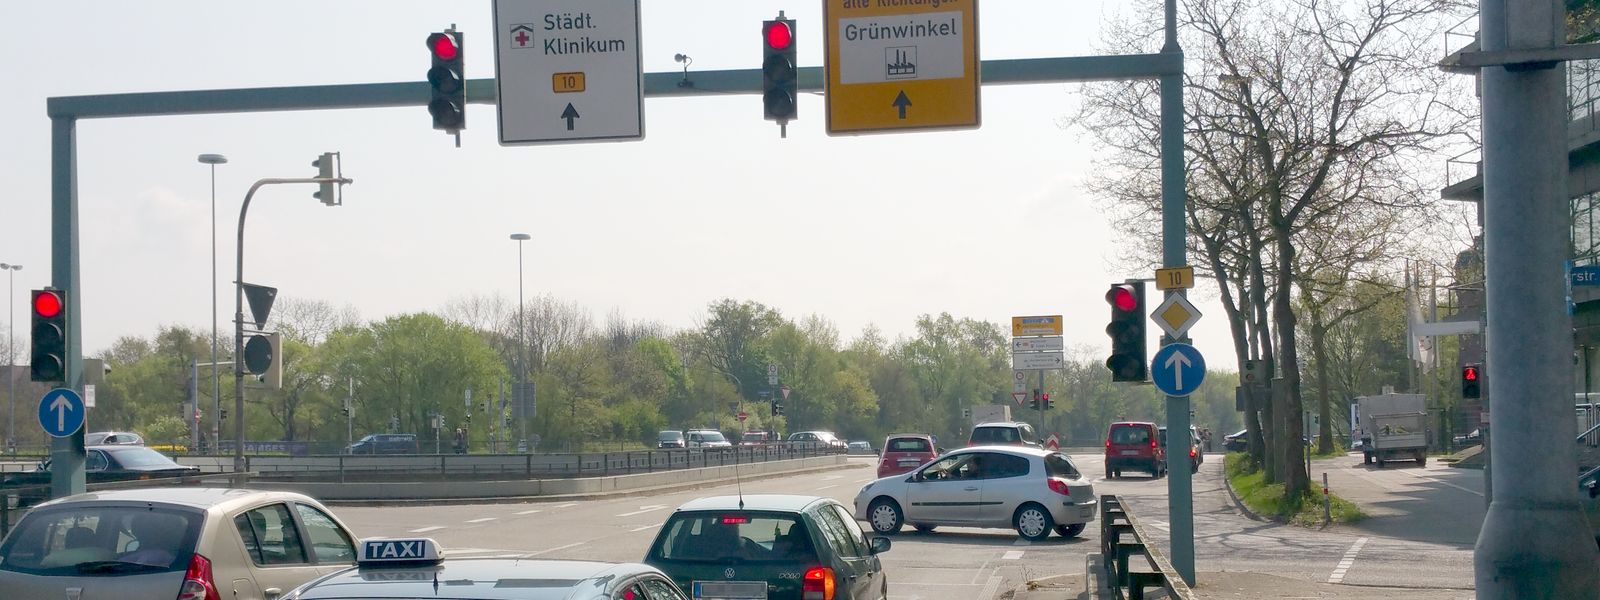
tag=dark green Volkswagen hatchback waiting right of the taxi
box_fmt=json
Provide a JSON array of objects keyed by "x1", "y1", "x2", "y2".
[{"x1": 645, "y1": 496, "x2": 890, "y2": 600}]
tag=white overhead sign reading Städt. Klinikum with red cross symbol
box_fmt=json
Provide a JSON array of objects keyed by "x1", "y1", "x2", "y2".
[{"x1": 494, "y1": 0, "x2": 645, "y2": 146}]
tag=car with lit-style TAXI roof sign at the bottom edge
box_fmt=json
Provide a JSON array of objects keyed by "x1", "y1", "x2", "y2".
[{"x1": 283, "y1": 538, "x2": 686, "y2": 600}]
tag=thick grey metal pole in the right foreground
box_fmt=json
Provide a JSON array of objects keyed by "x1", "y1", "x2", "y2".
[{"x1": 1474, "y1": 0, "x2": 1600, "y2": 598}]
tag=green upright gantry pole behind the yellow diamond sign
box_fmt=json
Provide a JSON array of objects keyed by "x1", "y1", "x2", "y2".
[{"x1": 1160, "y1": 0, "x2": 1195, "y2": 586}]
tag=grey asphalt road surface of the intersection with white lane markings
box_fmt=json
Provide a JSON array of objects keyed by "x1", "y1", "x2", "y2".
[{"x1": 336, "y1": 454, "x2": 1482, "y2": 600}]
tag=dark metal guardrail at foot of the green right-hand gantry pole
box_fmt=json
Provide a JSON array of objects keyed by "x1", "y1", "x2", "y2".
[{"x1": 1101, "y1": 494, "x2": 1197, "y2": 600}]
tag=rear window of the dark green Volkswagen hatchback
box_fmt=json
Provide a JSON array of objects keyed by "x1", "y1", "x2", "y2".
[{"x1": 650, "y1": 510, "x2": 816, "y2": 563}]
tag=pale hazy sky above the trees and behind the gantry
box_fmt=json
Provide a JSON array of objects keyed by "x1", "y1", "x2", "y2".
[{"x1": 0, "y1": 0, "x2": 1232, "y2": 368}]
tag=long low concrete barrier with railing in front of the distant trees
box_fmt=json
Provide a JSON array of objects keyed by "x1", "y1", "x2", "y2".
[{"x1": 178, "y1": 443, "x2": 845, "y2": 482}]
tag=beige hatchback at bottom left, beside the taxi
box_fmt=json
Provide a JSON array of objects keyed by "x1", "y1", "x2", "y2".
[{"x1": 0, "y1": 488, "x2": 355, "y2": 600}]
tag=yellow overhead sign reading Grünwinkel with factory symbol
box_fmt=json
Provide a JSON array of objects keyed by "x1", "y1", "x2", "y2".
[{"x1": 822, "y1": 0, "x2": 979, "y2": 134}]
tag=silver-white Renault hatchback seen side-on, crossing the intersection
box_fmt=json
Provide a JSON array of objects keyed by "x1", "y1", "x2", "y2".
[{"x1": 854, "y1": 446, "x2": 1099, "y2": 541}]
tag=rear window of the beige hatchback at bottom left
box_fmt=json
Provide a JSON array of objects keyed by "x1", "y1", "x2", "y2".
[{"x1": 0, "y1": 502, "x2": 202, "y2": 574}]
